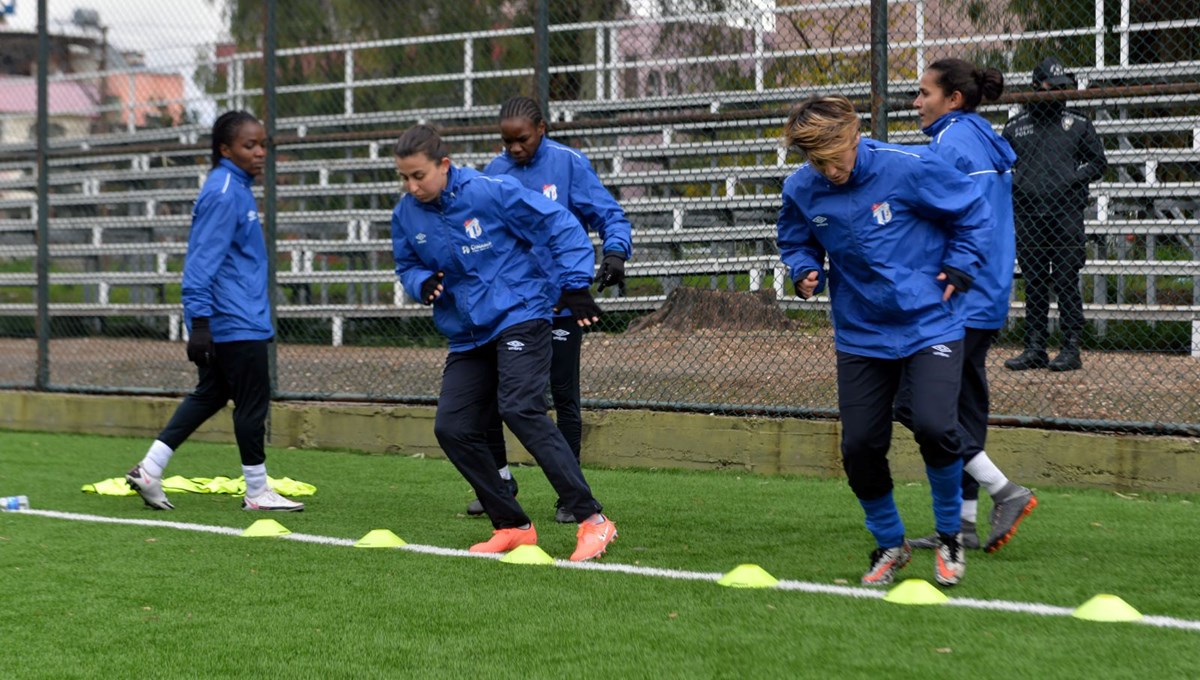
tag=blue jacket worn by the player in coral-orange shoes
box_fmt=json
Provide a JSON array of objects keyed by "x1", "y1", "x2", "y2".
[{"x1": 391, "y1": 166, "x2": 595, "y2": 351}]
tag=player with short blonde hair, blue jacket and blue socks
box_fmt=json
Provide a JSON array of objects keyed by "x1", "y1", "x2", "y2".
[{"x1": 779, "y1": 96, "x2": 992, "y2": 585}]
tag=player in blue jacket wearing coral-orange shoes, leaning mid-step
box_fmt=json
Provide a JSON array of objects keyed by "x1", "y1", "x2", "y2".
[{"x1": 391, "y1": 125, "x2": 617, "y2": 561}]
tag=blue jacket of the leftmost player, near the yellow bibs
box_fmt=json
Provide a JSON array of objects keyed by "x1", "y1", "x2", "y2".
[{"x1": 182, "y1": 158, "x2": 275, "y2": 342}]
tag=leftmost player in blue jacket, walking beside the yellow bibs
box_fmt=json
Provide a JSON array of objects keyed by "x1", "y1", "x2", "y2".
[{"x1": 125, "y1": 112, "x2": 304, "y2": 511}]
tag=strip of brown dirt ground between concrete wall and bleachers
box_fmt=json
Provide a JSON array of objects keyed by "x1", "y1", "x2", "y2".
[{"x1": 7, "y1": 327, "x2": 1200, "y2": 431}]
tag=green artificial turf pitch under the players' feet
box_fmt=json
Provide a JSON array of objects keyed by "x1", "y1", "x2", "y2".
[{"x1": 0, "y1": 432, "x2": 1200, "y2": 679}]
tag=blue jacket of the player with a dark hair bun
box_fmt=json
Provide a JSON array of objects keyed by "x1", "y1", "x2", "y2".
[{"x1": 922, "y1": 112, "x2": 1016, "y2": 330}]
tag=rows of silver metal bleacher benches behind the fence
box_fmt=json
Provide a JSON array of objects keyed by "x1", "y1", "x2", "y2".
[{"x1": 0, "y1": 50, "x2": 1200, "y2": 344}]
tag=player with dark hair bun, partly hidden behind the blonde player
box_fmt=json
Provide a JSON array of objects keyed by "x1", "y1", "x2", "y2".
[{"x1": 896, "y1": 59, "x2": 1038, "y2": 553}]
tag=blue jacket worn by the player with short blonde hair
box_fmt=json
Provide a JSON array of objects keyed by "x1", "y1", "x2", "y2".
[{"x1": 778, "y1": 139, "x2": 992, "y2": 359}]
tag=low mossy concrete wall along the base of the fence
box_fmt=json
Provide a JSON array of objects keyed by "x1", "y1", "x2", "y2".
[{"x1": 0, "y1": 391, "x2": 1200, "y2": 493}]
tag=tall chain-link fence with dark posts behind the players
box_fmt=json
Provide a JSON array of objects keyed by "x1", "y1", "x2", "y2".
[{"x1": 0, "y1": 0, "x2": 1200, "y2": 433}]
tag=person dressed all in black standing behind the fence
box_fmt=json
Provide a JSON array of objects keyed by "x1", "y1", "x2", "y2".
[{"x1": 1003, "y1": 56, "x2": 1108, "y2": 371}]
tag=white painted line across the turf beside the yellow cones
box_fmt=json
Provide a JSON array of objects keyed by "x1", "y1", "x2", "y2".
[{"x1": 12, "y1": 510, "x2": 1200, "y2": 632}]
